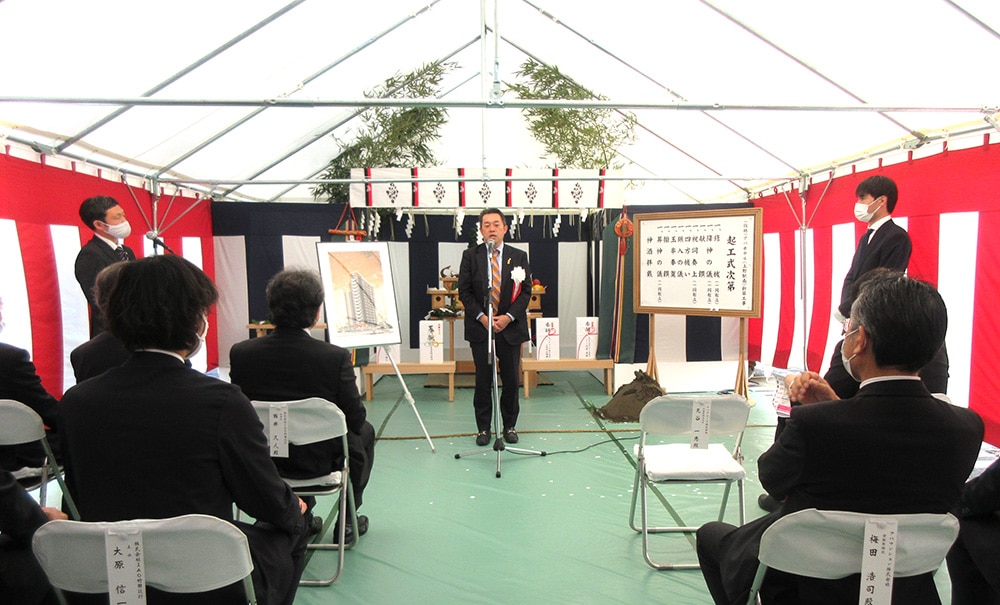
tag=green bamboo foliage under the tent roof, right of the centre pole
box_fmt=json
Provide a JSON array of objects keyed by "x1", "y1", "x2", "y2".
[{"x1": 507, "y1": 59, "x2": 636, "y2": 168}]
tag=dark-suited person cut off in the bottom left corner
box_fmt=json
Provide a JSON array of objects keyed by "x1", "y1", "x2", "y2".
[{"x1": 0, "y1": 471, "x2": 67, "y2": 605}]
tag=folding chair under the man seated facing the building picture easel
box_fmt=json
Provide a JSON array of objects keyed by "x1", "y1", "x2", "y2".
[{"x1": 253, "y1": 397, "x2": 358, "y2": 586}]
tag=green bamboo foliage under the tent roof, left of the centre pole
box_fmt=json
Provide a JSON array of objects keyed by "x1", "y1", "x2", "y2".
[{"x1": 312, "y1": 61, "x2": 456, "y2": 203}]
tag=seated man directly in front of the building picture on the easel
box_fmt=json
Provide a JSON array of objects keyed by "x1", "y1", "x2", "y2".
[{"x1": 229, "y1": 269, "x2": 375, "y2": 536}]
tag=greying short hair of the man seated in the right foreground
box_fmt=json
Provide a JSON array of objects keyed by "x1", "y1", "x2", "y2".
[{"x1": 851, "y1": 272, "x2": 948, "y2": 372}]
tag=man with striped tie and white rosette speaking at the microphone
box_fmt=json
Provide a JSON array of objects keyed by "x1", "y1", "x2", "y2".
[{"x1": 458, "y1": 208, "x2": 531, "y2": 445}]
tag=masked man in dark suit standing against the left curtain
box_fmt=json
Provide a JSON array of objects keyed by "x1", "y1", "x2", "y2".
[{"x1": 75, "y1": 195, "x2": 135, "y2": 338}]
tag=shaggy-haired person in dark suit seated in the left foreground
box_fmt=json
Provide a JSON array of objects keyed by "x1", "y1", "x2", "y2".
[{"x1": 59, "y1": 255, "x2": 307, "y2": 605}]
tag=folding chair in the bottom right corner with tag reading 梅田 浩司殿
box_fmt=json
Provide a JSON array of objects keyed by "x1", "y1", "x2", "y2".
[{"x1": 747, "y1": 508, "x2": 958, "y2": 605}]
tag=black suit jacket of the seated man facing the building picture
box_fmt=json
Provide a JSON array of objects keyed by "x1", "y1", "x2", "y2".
[{"x1": 229, "y1": 328, "x2": 367, "y2": 478}]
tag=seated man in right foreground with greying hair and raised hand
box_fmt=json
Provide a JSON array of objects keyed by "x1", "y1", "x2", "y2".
[{"x1": 697, "y1": 273, "x2": 983, "y2": 605}]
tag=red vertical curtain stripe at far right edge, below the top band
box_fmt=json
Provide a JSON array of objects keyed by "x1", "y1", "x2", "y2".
[{"x1": 969, "y1": 212, "x2": 1000, "y2": 444}]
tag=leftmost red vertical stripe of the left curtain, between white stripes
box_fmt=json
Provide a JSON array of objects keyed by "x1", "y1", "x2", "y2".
[{"x1": 17, "y1": 222, "x2": 63, "y2": 399}]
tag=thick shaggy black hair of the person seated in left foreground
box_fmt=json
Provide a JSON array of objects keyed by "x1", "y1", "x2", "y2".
[{"x1": 106, "y1": 254, "x2": 219, "y2": 351}]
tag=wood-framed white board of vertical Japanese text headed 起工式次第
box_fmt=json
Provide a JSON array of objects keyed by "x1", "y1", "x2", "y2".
[{"x1": 633, "y1": 208, "x2": 763, "y2": 317}]
